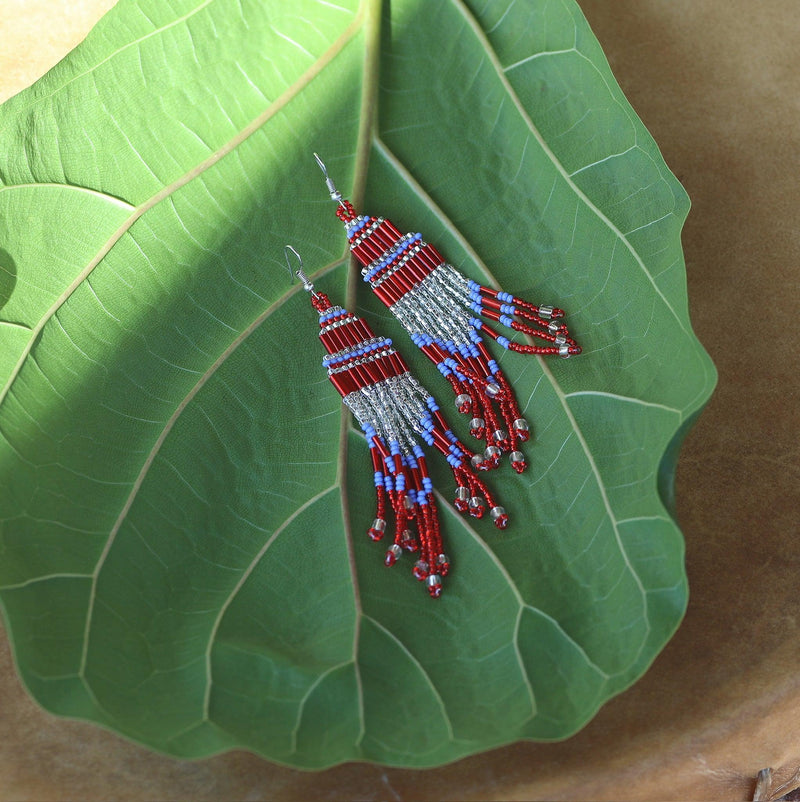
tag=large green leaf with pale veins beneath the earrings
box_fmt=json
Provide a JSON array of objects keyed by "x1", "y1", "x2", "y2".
[{"x1": 0, "y1": 0, "x2": 715, "y2": 767}]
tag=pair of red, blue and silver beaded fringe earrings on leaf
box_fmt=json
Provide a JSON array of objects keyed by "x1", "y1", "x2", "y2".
[{"x1": 286, "y1": 153, "x2": 581, "y2": 598}]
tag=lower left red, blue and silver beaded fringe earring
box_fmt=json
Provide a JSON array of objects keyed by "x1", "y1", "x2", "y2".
[{"x1": 296, "y1": 253, "x2": 508, "y2": 598}]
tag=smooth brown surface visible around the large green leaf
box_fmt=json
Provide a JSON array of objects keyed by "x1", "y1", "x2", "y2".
[{"x1": 0, "y1": 0, "x2": 800, "y2": 802}]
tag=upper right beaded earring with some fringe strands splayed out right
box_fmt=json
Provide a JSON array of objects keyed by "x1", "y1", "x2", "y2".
[{"x1": 314, "y1": 154, "x2": 581, "y2": 473}]
